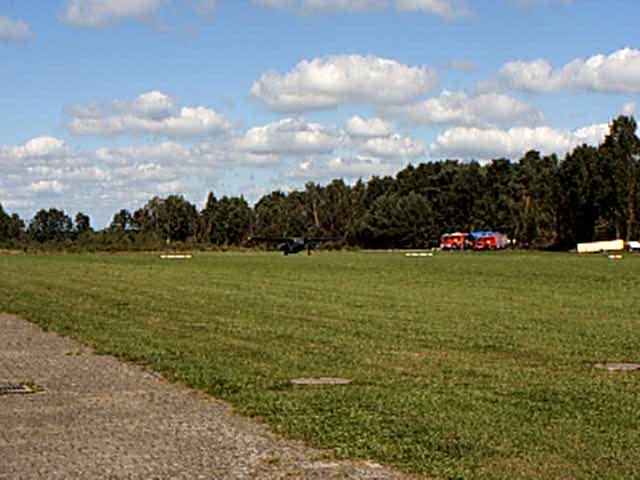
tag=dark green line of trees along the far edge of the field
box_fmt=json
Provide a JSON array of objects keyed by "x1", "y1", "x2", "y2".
[{"x1": 0, "y1": 116, "x2": 640, "y2": 250}]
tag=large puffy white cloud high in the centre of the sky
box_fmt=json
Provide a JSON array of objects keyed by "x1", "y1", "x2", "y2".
[{"x1": 251, "y1": 55, "x2": 438, "y2": 112}]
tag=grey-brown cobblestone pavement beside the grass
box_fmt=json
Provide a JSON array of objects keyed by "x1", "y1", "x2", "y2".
[{"x1": 0, "y1": 314, "x2": 410, "y2": 480}]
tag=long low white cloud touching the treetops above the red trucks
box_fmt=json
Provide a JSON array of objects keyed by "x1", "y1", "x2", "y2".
[{"x1": 430, "y1": 123, "x2": 609, "y2": 160}]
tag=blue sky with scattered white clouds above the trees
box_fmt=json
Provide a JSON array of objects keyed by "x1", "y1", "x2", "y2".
[{"x1": 0, "y1": 0, "x2": 640, "y2": 226}]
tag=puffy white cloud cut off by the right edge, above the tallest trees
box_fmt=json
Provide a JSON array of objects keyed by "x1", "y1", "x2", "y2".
[{"x1": 500, "y1": 48, "x2": 640, "y2": 93}]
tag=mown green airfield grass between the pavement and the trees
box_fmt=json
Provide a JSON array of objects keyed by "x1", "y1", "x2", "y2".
[{"x1": 0, "y1": 252, "x2": 640, "y2": 479}]
